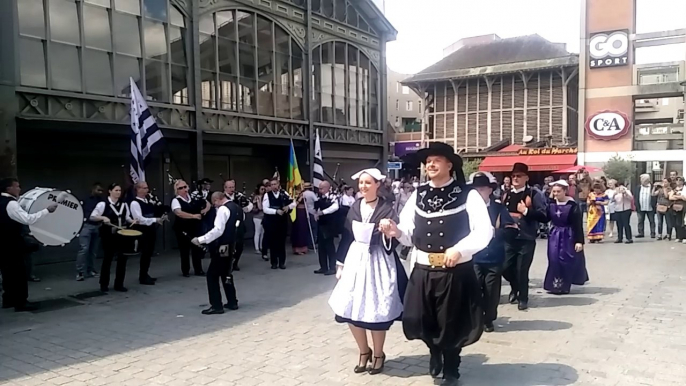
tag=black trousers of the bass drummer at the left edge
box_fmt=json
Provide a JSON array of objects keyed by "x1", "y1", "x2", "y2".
[{"x1": 0, "y1": 248, "x2": 29, "y2": 307}]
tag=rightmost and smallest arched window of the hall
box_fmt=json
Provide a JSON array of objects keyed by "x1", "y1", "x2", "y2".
[{"x1": 312, "y1": 42, "x2": 379, "y2": 130}]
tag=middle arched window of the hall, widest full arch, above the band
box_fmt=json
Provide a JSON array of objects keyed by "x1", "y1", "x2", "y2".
[{"x1": 200, "y1": 10, "x2": 304, "y2": 119}]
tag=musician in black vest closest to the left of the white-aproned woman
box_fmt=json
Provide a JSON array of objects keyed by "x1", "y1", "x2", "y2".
[{"x1": 314, "y1": 181, "x2": 339, "y2": 275}]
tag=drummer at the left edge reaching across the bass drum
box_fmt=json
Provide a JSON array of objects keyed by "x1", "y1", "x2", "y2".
[{"x1": 0, "y1": 178, "x2": 57, "y2": 311}]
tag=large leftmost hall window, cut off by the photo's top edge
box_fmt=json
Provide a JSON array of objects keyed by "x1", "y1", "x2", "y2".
[{"x1": 17, "y1": 0, "x2": 189, "y2": 104}]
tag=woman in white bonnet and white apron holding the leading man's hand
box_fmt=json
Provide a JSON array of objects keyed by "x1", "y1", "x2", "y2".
[{"x1": 329, "y1": 168, "x2": 407, "y2": 374}]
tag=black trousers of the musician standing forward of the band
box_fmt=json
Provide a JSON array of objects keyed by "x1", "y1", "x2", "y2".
[{"x1": 207, "y1": 244, "x2": 238, "y2": 310}]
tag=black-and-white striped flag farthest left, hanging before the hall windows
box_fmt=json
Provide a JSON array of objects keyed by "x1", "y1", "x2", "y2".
[{"x1": 129, "y1": 78, "x2": 163, "y2": 184}]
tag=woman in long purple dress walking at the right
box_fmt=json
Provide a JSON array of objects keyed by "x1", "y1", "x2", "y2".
[{"x1": 543, "y1": 180, "x2": 588, "y2": 295}]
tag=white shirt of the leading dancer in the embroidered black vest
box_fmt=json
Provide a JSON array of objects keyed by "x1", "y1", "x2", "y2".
[{"x1": 398, "y1": 180, "x2": 493, "y2": 267}]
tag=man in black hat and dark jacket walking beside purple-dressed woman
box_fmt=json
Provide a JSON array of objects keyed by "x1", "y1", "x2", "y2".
[{"x1": 503, "y1": 162, "x2": 547, "y2": 311}]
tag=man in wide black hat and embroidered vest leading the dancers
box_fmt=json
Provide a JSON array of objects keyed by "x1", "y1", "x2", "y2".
[{"x1": 380, "y1": 142, "x2": 493, "y2": 386}]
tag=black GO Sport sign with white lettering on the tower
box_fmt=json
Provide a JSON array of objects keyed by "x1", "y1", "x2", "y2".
[{"x1": 588, "y1": 30, "x2": 629, "y2": 68}]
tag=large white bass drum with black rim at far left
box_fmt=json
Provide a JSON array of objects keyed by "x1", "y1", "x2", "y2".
[{"x1": 17, "y1": 188, "x2": 83, "y2": 246}]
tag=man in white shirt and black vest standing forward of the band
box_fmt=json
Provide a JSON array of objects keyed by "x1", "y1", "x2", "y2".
[{"x1": 191, "y1": 192, "x2": 243, "y2": 315}]
